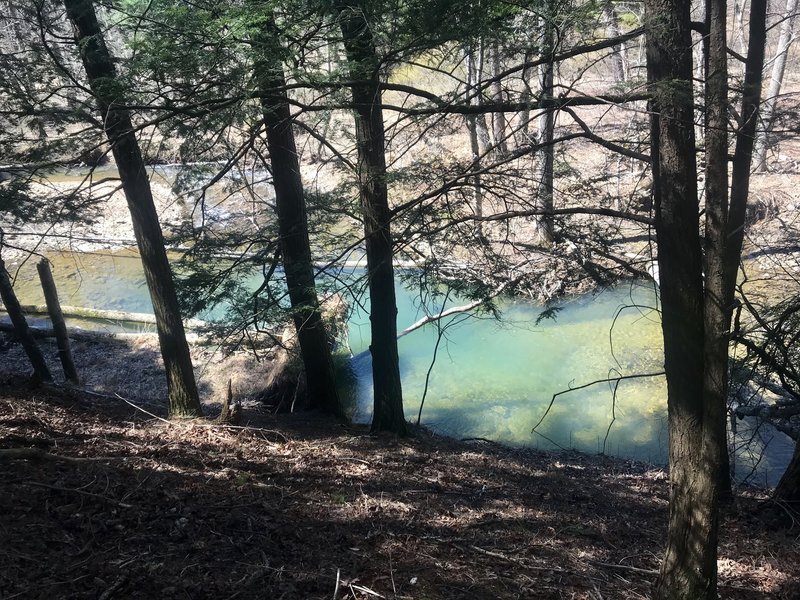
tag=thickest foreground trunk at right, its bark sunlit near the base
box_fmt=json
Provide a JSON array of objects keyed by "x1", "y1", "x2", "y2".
[{"x1": 645, "y1": 0, "x2": 718, "y2": 600}]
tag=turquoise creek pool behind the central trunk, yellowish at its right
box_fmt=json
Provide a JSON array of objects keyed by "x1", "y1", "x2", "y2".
[{"x1": 350, "y1": 284, "x2": 666, "y2": 462}]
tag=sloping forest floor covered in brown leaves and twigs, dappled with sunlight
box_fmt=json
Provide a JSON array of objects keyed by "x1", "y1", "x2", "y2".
[{"x1": 0, "y1": 374, "x2": 800, "y2": 600}]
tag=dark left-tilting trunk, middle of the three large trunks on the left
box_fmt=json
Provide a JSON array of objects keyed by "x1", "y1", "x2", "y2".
[{"x1": 254, "y1": 20, "x2": 341, "y2": 414}]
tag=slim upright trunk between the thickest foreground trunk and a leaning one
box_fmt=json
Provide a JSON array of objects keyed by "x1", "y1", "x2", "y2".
[{"x1": 703, "y1": 0, "x2": 733, "y2": 498}]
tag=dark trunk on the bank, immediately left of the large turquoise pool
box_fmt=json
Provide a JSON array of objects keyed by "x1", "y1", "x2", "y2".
[{"x1": 336, "y1": 0, "x2": 407, "y2": 435}]
